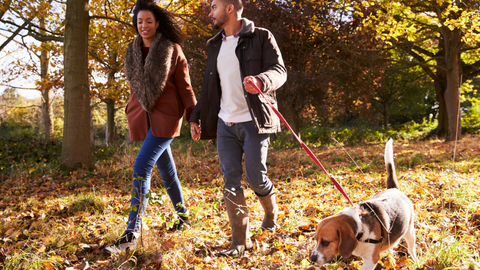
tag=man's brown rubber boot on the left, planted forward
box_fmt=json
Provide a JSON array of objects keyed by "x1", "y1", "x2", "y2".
[{"x1": 217, "y1": 189, "x2": 253, "y2": 258}]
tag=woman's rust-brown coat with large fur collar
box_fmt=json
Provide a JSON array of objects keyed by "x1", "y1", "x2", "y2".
[{"x1": 125, "y1": 33, "x2": 197, "y2": 141}]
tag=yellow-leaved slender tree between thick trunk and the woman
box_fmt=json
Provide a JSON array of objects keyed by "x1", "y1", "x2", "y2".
[{"x1": 88, "y1": 0, "x2": 135, "y2": 144}]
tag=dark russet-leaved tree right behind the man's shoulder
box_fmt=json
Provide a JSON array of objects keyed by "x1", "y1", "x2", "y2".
[{"x1": 245, "y1": 0, "x2": 384, "y2": 131}]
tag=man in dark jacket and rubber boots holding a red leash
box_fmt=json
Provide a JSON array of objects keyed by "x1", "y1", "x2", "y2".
[{"x1": 189, "y1": 0, "x2": 287, "y2": 257}]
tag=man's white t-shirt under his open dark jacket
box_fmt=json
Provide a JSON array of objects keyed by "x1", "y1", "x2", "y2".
[{"x1": 217, "y1": 35, "x2": 252, "y2": 123}]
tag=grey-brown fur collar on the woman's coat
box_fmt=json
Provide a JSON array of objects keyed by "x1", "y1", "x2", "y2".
[{"x1": 125, "y1": 33, "x2": 174, "y2": 113}]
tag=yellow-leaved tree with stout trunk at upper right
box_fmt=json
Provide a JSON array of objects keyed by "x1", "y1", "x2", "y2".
[{"x1": 356, "y1": 0, "x2": 480, "y2": 140}]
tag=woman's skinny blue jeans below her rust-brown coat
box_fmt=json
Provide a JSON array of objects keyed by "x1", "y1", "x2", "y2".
[{"x1": 127, "y1": 130, "x2": 187, "y2": 232}]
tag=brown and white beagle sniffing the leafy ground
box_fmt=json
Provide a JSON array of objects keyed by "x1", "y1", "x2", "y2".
[{"x1": 310, "y1": 139, "x2": 416, "y2": 270}]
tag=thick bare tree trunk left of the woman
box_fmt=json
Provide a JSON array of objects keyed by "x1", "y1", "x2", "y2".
[{"x1": 61, "y1": 0, "x2": 94, "y2": 169}]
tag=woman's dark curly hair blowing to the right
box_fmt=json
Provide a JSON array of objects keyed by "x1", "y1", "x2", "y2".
[{"x1": 132, "y1": 0, "x2": 184, "y2": 43}]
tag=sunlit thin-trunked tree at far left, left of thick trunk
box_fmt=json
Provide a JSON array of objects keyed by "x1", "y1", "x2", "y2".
[{"x1": 0, "y1": 0, "x2": 64, "y2": 137}]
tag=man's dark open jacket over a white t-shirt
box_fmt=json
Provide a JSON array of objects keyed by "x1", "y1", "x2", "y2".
[{"x1": 189, "y1": 18, "x2": 287, "y2": 139}]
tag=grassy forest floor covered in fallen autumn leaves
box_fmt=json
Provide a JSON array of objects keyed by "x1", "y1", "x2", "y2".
[{"x1": 0, "y1": 135, "x2": 480, "y2": 270}]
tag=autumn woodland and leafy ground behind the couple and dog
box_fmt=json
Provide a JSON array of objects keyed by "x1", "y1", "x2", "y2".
[{"x1": 0, "y1": 0, "x2": 480, "y2": 269}]
